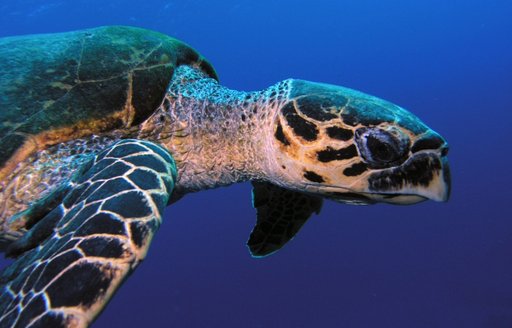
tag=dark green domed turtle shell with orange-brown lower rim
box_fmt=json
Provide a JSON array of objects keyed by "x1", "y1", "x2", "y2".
[{"x1": 0, "y1": 26, "x2": 217, "y2": 181}]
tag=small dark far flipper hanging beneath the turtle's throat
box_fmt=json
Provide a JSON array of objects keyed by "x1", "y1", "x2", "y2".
[{"x1": 247, "y1": 182, "x2": 322, "y2": 257}]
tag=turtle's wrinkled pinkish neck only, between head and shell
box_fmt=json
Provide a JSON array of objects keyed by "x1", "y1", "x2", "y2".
[{"x1": 138, "y1": 66, "x2": 288, "y2": 197}]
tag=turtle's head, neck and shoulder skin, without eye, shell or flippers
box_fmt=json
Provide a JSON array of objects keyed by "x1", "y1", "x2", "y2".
[{"x1": 0, "y1": 65, "x2": 449, "y2": 239}]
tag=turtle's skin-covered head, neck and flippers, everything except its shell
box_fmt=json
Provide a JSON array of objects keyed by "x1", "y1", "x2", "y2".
[{"x1": 0, "y1": 66, "x2": 449, "y2": 327}]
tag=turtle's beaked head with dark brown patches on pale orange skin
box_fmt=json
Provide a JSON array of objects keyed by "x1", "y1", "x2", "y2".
[{"x1": 271, "y1": 80, "x2": 450, "y2": 204}]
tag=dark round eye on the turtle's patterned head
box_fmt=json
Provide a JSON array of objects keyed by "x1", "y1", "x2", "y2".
[{"x1": 356, "y1": 128, "x2": 408, "y2": 168}]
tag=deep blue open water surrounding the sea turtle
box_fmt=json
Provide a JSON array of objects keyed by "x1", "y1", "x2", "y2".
[{"x1": 0, "y1": 0, "x2": 512, "y2": 328}]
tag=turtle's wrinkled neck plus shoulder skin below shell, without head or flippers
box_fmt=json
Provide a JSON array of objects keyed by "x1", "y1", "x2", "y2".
[{"x1": 0, "y1": 66, "x2": 287, "y2": 241}]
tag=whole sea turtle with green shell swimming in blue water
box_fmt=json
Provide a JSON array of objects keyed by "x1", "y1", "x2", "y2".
[{"x1": 0, "y1": 26, "x2": 450, "y2": 327}]
